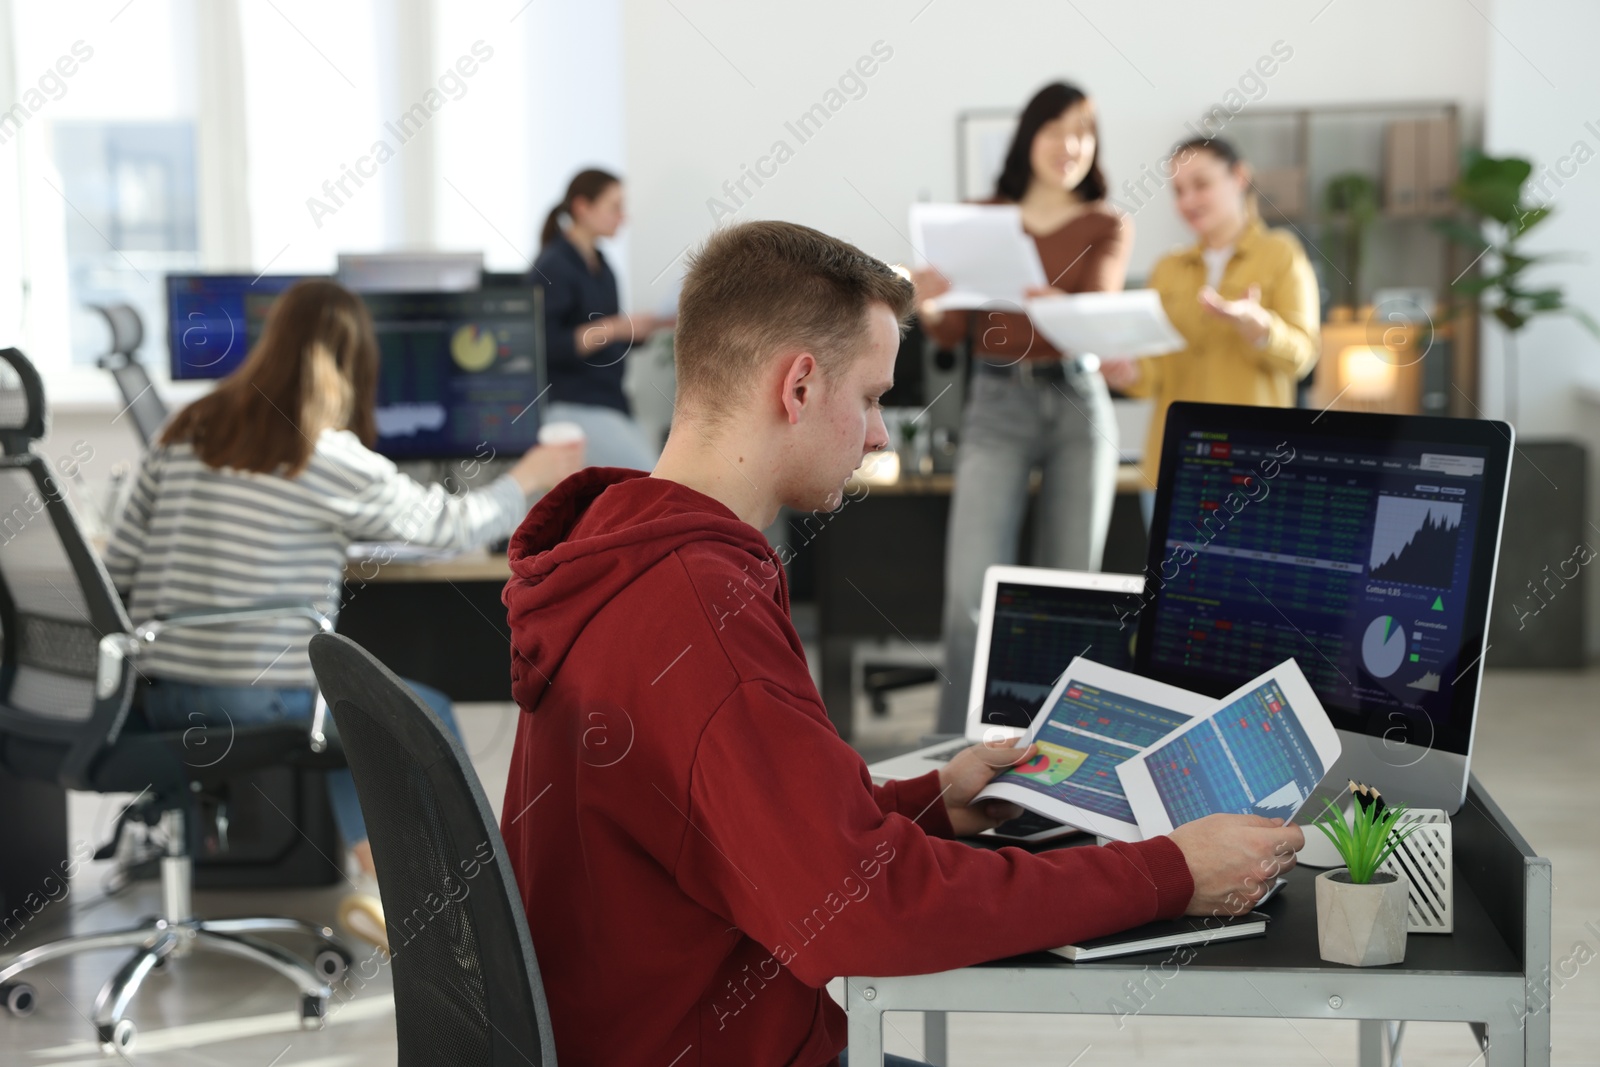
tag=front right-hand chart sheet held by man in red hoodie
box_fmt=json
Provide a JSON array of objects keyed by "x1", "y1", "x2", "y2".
[{"x1": 1117, "y1": 659, "x2": 1341, "y2": 837}]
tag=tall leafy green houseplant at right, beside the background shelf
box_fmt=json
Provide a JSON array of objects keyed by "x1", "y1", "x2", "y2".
[{"x1": 1435, "y1": 149, "x2": 1600, "y2": 424}]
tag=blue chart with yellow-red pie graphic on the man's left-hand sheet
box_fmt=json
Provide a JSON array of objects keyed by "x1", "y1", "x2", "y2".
[{"x1": 995, "y1": 681, "x2": 1189, "y2": 822}]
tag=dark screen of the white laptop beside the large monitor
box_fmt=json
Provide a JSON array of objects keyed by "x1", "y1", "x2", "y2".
[{"x1": 978, "y1": 568, "x2": 1139, "y2": 729}]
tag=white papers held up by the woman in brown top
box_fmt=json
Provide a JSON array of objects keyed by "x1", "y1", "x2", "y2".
[{"x1": 910, "y1": 203, "x2": 1046, "y2": 310}]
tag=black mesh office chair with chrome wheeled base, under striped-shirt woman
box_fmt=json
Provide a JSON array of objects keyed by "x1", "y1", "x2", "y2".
[{"x1": 0, "y1": 349, "x2": 352, "y2": 1051}]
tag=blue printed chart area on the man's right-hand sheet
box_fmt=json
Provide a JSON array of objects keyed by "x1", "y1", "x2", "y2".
[{"x1": 1144, "y1": 681, "x2": 1326, "y2": 825}]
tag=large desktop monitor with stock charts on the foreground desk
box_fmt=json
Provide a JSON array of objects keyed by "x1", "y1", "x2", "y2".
[{"x1": 1136, "y1": 403, "x2": 1510, "y2": 817}]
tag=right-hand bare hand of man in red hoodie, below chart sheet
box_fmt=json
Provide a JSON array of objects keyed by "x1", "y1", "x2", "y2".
[{"x1": 1171, "y1": 809, "x2": 1306, "y2": 915}]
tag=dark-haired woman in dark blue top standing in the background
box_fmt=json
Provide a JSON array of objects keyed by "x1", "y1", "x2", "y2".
[{"x1": 533, "y1": 170, "x2": 669, "y2": 470}]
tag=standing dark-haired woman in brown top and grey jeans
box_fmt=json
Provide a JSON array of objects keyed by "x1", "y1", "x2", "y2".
[{"x1": 917, "y1": 82, "x2": 1133, "y2": 733}]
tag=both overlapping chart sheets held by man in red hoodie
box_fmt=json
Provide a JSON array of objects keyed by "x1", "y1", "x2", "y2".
[{"x1": 973, "y1": 656, "x2": 1341, "y2": 841}]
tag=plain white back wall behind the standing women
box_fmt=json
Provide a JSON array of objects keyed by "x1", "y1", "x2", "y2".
[{"x1": 624, "y1": 0, "x2": 1484, "y2": 307}]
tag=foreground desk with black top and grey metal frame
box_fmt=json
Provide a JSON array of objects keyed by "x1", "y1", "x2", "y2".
[{"x1": 845, "y1": 776, "x2": 1550, "y2": 1067}]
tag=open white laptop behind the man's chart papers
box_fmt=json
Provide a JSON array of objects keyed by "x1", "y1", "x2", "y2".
[{"x1": 867, "y1": 566, "x2": 1144, "y2": 841}]
